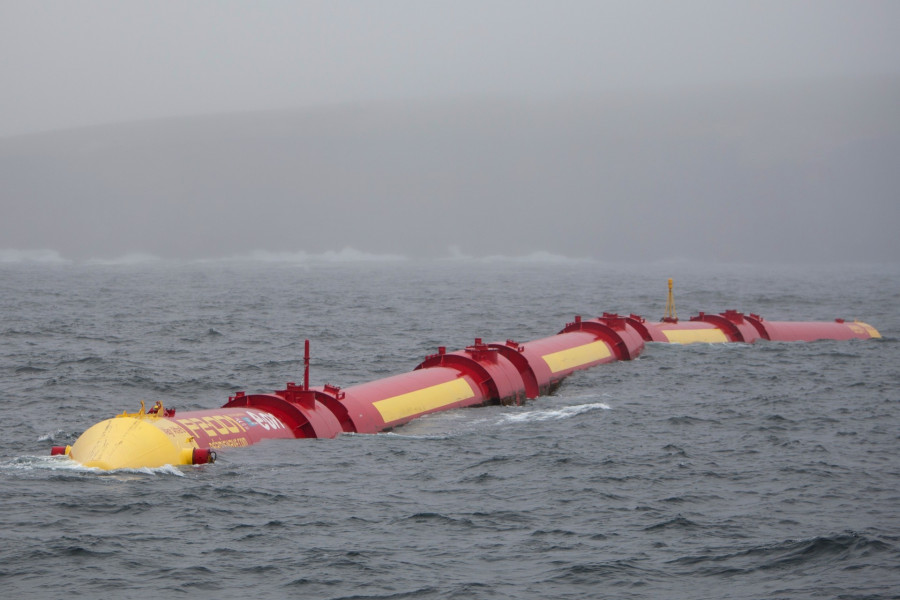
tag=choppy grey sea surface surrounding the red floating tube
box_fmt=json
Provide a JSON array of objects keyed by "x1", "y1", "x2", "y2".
[{"x1": 0, "y1": 253, "x2": 900, "y2": 600}]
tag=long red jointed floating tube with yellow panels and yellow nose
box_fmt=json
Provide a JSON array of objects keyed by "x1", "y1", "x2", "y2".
[{"x1": 51, "y1": 282, "x2": 881, "y2": 470}]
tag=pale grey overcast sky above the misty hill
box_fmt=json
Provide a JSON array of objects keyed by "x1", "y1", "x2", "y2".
[{"x1": 0, "y1": 0, "x2": 900, "y2": 136}]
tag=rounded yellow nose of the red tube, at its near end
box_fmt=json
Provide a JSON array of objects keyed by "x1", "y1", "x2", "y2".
[{"x1": 69, "y1": 417, "x2": 192, "y2": 470}]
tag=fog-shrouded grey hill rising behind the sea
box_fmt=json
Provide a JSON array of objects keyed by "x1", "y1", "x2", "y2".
[{"x1": 0, "y1": 80, "x2": 900, "y2": 262}]
